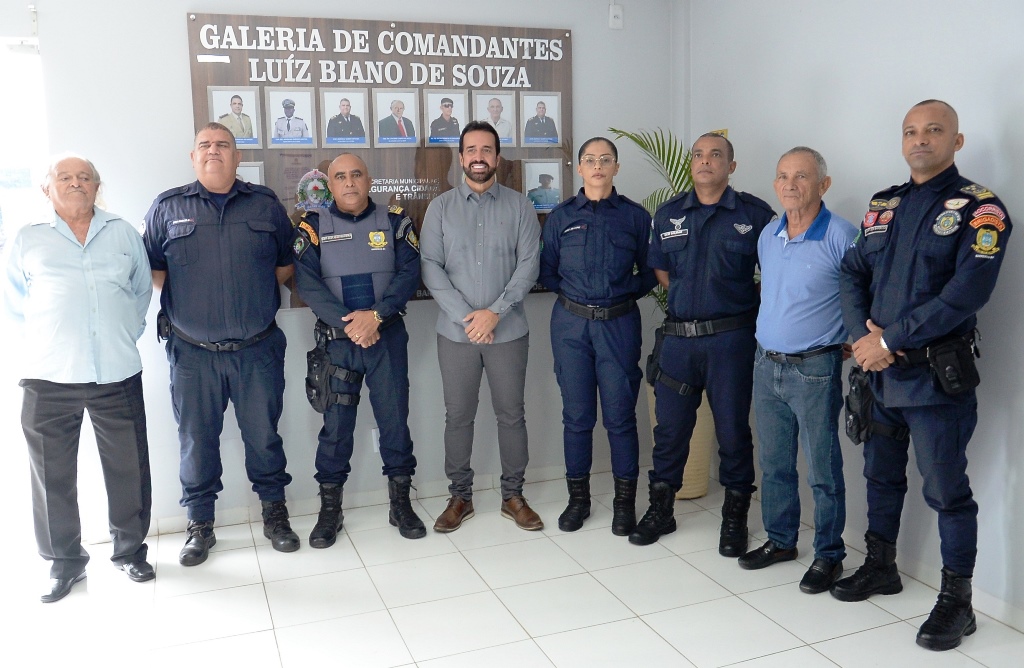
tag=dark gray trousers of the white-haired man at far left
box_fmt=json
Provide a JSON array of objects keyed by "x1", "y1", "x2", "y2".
[{"x1": 19, "y1": 372, "x2": 153, "y2": 579}]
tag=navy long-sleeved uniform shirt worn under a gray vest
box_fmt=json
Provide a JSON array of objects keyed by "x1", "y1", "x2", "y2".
[{"x1": 295, "y1": 200, "x2": 420, "y2": 327}]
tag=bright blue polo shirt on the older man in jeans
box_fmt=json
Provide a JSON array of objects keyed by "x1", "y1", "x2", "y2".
[{"x1": 757, "y1": 202, "x2": 857, "y2": 353}]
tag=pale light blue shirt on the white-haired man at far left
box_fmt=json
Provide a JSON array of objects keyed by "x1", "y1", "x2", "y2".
[{"x1": 4, "y1": 209, "x2": 153, "y2": 384}]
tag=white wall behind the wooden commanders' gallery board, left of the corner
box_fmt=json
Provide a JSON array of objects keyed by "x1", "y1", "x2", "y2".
[{"x1": 19, "y1": 0, "x2": 672, "y2": 536}]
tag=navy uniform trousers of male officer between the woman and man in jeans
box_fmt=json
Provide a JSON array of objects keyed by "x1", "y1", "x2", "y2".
[{"x1": 650, "y1": 327, "x2": 757, "y2": 493}]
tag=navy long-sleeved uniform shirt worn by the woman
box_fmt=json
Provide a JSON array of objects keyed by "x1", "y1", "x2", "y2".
[{"x1": 540, "y1": 189, "x2": 657, "y2": 306}]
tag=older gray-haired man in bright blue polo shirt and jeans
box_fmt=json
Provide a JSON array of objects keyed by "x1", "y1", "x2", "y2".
[{"x1": 739, "y1": 147, "x2": 857, "y2": 594}]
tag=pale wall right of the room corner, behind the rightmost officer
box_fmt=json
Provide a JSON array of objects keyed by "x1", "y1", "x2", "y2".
[{"x1": 688, "y1": 0, "x2": 1024, "y2": 628}]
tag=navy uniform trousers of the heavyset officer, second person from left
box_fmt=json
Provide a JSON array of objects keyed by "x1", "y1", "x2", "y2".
[{"x1": 167, "y1": 328, "x2": 292, "y2": 521}]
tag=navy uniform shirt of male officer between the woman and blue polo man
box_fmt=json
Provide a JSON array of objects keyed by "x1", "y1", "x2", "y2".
[{"x1": 647, "y1": 186, "x2": 775, "y2": 321}]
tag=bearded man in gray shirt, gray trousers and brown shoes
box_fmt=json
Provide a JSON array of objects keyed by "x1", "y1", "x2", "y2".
[{"x1": 420, "y1": 121, "x2": 544, "y2": 533}]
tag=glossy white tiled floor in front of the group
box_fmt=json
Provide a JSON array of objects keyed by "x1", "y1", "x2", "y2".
[{"x1": 9, "y1": 474, "x2": 1024, "y2": 668}]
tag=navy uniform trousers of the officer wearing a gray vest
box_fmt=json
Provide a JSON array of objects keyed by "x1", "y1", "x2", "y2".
[{"x1": 314, "y1": 319, "x2": 416, "y2": 485}]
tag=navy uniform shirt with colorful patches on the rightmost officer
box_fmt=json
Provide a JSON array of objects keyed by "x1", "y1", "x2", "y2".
[{"x1": 840, "y1": 165, "x2": 1012, "y2": 407}]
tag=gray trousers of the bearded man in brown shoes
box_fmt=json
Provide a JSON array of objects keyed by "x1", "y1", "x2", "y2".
[{"x1": 437, "y1": 334, "x2": 529, "y2": 500}]
